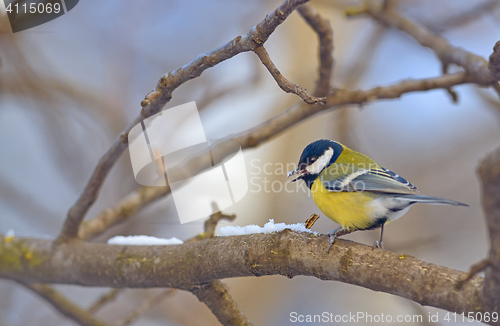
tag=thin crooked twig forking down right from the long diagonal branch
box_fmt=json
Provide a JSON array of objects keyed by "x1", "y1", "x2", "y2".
[{"x1": 253, "y1": 46, "x2": 326, "y2": 104}]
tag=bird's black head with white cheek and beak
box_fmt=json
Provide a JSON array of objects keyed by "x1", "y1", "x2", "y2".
[{"x1": 287, "y1": 139, "x2": 343, "y2": 187}]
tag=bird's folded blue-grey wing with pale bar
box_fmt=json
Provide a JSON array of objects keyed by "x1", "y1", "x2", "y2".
[{"x1": 323, "y1": 167, "x2": 420, "y2": 194}]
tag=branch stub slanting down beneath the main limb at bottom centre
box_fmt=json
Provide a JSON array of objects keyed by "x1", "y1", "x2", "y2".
[{"x1": 189, "y1": 280, "x2": 252, "y2": 326}]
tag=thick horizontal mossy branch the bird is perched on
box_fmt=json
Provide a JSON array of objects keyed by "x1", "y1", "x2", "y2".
[{"x1": 0, "y1": 230, "x2": 487, "y2": 320}]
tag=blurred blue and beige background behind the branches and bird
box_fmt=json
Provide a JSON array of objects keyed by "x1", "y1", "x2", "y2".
[{"x1": 0, "y1": 0, "x2": 500, "y2": 326}]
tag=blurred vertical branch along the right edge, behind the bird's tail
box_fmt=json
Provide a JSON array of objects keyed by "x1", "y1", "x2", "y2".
[{"x1": 478, "y1": 148, "x2": 500, "y2": 312}]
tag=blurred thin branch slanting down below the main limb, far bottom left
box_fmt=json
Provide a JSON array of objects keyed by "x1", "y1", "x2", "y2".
[{"x1": 19, "y1": 282, "x2": 106, "y2": 326}]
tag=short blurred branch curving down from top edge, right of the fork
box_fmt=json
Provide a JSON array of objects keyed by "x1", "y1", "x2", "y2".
[{"x1": 297, "y1": 3, "x2": 334, "y2": 97}]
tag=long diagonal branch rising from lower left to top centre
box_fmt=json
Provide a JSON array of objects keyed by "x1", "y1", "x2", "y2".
[{"x1": 60, "y1": 0, "x2": 308, "y2": 241}]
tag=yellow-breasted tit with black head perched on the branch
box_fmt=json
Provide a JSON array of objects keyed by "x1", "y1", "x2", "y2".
[{"x1": 287, "y1": 139, "x2": 469, "y2": 252}]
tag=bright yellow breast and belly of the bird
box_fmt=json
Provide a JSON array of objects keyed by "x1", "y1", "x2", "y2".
[{"x1": 311, "y1": 178, "x2": 375, "y2": 230}]
